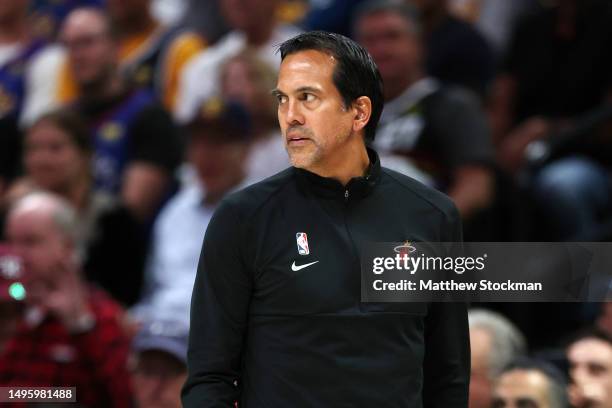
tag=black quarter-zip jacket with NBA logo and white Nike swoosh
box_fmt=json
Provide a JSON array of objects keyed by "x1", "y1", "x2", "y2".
[{"x1": 182, "y1": 150, "x2": 470, "y2": 408}]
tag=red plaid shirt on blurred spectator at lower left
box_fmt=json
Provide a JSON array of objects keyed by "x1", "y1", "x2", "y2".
[{"x1": 0, "y1": 289, "x2": 132, "y2": 407}]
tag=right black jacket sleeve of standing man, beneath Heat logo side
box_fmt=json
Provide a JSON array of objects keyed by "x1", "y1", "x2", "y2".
[{"x1": 423, "y1": 206, "x2": 470, "y2": 408}]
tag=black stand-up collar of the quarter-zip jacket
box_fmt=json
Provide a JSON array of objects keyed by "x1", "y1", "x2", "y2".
[{"x1": 294, "y1": 147, "x2": 380, "y2": 201}]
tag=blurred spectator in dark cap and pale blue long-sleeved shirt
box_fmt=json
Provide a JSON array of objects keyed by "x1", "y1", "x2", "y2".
[{"x1": 133, "y1": 100, "x2": 251, "y2": 323}]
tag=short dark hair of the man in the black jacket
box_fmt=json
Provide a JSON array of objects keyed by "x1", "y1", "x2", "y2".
[{"x1": 279, "y1": 31, "x2": 384, "y2": 141}]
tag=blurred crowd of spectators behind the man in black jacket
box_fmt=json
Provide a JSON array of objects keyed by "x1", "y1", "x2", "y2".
[{"x1": 0, "y1": 0, "x2": 612, "y2": 408}]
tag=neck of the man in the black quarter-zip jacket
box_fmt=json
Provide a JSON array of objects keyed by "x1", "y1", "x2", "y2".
[{"x1": 306, "y1": 139, "x2": 370, "y2": 186}]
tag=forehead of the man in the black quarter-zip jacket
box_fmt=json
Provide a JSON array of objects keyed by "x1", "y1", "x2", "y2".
[{"x1": 278, "y1": 50, "x2": 336, "y2": 92}]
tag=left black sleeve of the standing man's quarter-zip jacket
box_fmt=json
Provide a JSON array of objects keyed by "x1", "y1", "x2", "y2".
[{"x1": 182, "y1": 202, "x2": 252, "y2": 408}]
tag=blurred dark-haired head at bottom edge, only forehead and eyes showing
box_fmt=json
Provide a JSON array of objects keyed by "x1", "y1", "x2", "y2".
[{"x1": 491, "y1": 359, "x2": 569, "y2": 408}]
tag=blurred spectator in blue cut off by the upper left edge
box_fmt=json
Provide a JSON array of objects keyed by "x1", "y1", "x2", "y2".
[{"x1": 0, "y1": 0, "x2": 44, "y2": 197}]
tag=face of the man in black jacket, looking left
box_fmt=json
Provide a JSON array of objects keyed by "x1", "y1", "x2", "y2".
[{"x1": 275, "y1": 50, "x2": 355, "y2": 173}]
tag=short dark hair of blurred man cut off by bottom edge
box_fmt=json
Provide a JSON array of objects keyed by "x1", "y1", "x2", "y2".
[{"x1": 501, "y1": 358, "x2": 569, "y2": 408}]
